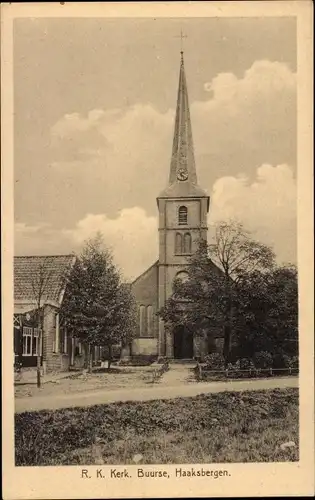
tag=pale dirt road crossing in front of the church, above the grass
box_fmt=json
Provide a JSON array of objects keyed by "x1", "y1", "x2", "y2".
[{"x1": 15, "y1": 375, "x2": 299, "y2": 413}]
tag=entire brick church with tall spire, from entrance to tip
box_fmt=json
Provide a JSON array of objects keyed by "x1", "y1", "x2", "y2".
[{"x1": 129, "y1": 52, "x2": 210, "y2": 359}]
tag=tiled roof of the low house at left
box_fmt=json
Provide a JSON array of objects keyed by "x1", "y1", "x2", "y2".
[{"x1": 14, "y1": 255, "x2": 75, "y2": 303}]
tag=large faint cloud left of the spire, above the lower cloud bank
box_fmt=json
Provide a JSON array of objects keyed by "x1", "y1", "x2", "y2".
[{"x1": 46, "y1": 104, "x2": 174, "y2": 217}]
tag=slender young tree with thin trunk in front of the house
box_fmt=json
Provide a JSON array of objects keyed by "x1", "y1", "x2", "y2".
[{"x1": 31, "y1": 256, "x2": 54, "y2": 387}]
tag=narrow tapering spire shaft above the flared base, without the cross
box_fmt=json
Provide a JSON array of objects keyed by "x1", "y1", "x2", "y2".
[{"x1": 169, "y1": 51, "x2": 197, "y2": 184}]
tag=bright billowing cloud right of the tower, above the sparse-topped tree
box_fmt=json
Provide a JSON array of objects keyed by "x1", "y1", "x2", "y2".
[{"x1": 209, "y1": 164, "x2": 297, "y2": 263}]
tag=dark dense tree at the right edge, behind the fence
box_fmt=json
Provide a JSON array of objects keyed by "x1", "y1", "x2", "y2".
[{"x1": 234, "y1": 265, "x2": 298, "y2": 358}]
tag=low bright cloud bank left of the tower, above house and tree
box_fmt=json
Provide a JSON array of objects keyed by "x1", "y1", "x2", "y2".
[{"x1": 15, "y1": 207, "x2": 158, "y2": 279}]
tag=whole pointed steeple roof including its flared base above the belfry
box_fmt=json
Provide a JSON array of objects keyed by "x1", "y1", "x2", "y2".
[{"x1": 159, "y1": 52, "x2": 208, "y2": 202}]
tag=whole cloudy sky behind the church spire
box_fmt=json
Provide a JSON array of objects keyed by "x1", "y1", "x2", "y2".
[{"x1": 14, "y1": 17, "x2": 297, "y2": 279}]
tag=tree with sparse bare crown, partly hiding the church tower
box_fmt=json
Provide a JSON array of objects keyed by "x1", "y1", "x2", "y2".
[{"x1": 161, "y1": 221, "x2": 275, "y2": 364}]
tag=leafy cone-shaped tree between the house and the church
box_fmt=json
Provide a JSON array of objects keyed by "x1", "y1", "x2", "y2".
[{"x1": 60, "y1": 234, "x2": 135, "y2": 371}]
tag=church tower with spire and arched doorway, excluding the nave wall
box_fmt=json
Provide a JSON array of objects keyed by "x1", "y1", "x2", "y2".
[{"x1": 157, "y1": 52, "x2": 210, "y2": 358}]
